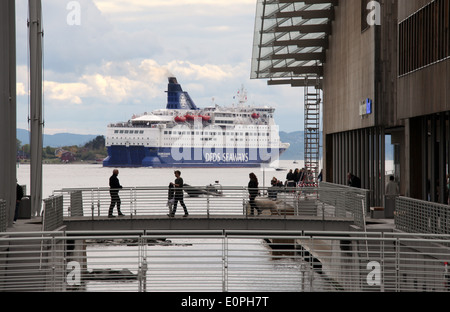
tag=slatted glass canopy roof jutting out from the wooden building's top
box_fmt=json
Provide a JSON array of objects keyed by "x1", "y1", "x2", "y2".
[{"x1": 251, "y1": 0, "x2": 338, "y2": 86}]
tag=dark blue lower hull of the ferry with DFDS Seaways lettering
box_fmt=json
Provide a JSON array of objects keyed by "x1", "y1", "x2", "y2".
[{"x1": 103, "y1": 146, "x2": 286, "y2": 168}]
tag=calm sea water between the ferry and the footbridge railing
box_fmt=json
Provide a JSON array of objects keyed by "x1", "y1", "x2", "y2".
[{"x1": 17, "y1": 160, "x2": 303, "y2": 198}]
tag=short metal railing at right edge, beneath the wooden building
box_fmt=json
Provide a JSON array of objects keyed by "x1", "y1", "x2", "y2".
[{"x1": 395, "y1": 196, "x2": 450, "y2": 234}]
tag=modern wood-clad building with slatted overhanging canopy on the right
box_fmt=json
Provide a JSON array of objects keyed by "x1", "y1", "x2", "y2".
[{"x1": 252, "y1": 0, "x2": 450, "y2": 206}]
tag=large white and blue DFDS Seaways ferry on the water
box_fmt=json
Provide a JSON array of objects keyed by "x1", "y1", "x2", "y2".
[{"x1": 103, "y1": 77, "x2": 289, "y2": 168}]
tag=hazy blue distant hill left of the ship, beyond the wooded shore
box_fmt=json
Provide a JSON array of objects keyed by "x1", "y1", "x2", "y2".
[{"x1": 16, "y1": 129, "x2": 97, "y2": 147}]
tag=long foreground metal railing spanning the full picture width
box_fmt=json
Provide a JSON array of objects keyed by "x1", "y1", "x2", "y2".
[{"x1": 0, "y1": 231, "x2": 450, "y2": 292}]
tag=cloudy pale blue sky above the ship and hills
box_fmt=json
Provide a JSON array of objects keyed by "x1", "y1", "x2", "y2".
[{"x1": 16, "y1": 0, "x2": 304, "y2": 135}]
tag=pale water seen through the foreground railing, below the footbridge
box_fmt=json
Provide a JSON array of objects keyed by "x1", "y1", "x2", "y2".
[{"x1": 86, "y1": 238, "x2": 312, "y2": 292}]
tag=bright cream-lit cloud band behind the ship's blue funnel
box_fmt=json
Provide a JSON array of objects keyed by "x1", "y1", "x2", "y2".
[{"x1": 44, "y1": 59, "x2": 245, "y2": 106}]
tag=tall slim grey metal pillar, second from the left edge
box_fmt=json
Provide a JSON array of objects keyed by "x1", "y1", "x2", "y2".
[{"x1": 28, "y1": 0, "x2": 43, "y2": 216}]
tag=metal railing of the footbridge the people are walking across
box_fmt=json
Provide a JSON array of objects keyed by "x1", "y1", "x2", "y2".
[{"x1": 48, "y1": 186, "x2": 365, "y2": 223}]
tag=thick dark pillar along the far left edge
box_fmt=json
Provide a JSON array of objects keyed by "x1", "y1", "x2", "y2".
[{"x1": 0, "y1": 0, "x2": 16, "y2": 231}]
